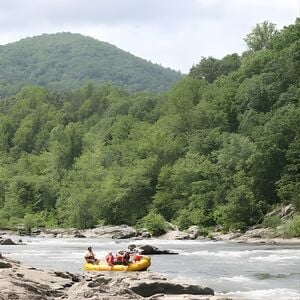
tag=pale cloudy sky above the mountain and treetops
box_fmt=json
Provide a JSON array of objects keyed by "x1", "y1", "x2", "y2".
[{"x1": 0, "y1": 0, "x2": 300, "y2": 73}]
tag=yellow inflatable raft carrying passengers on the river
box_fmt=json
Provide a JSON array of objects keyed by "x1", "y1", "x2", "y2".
[{"x1": 83, "y1": 256, "x2": 151, "y2": 272}]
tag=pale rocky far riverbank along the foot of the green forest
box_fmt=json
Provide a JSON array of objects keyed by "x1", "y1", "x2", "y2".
[{"x1": 0, "y1": 205, "x2": 300, "y2": 244}]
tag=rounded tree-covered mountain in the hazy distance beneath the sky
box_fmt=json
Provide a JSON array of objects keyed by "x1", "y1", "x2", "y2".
[{"x1": 0, "y1": 33, "x2": 182, "y2": 96}]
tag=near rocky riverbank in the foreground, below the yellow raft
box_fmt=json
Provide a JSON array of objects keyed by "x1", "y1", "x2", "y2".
[{"x1": 0, "y1": 256, "x2": 230, "y2": 300}]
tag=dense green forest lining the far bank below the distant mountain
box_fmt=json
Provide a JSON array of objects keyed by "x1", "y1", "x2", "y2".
[{"x1": 0, "y1": 19, "x2": 300, "y2": 234}]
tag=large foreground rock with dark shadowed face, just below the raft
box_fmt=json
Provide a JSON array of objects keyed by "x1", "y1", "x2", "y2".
[{"x1": 68, "y1": 272, "x2": 214, "y2": 300}]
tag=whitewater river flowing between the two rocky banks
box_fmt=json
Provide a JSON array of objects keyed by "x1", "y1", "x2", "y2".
[{"x1": 0, "y1": 236, "x2": 300, "y2": 300}]
